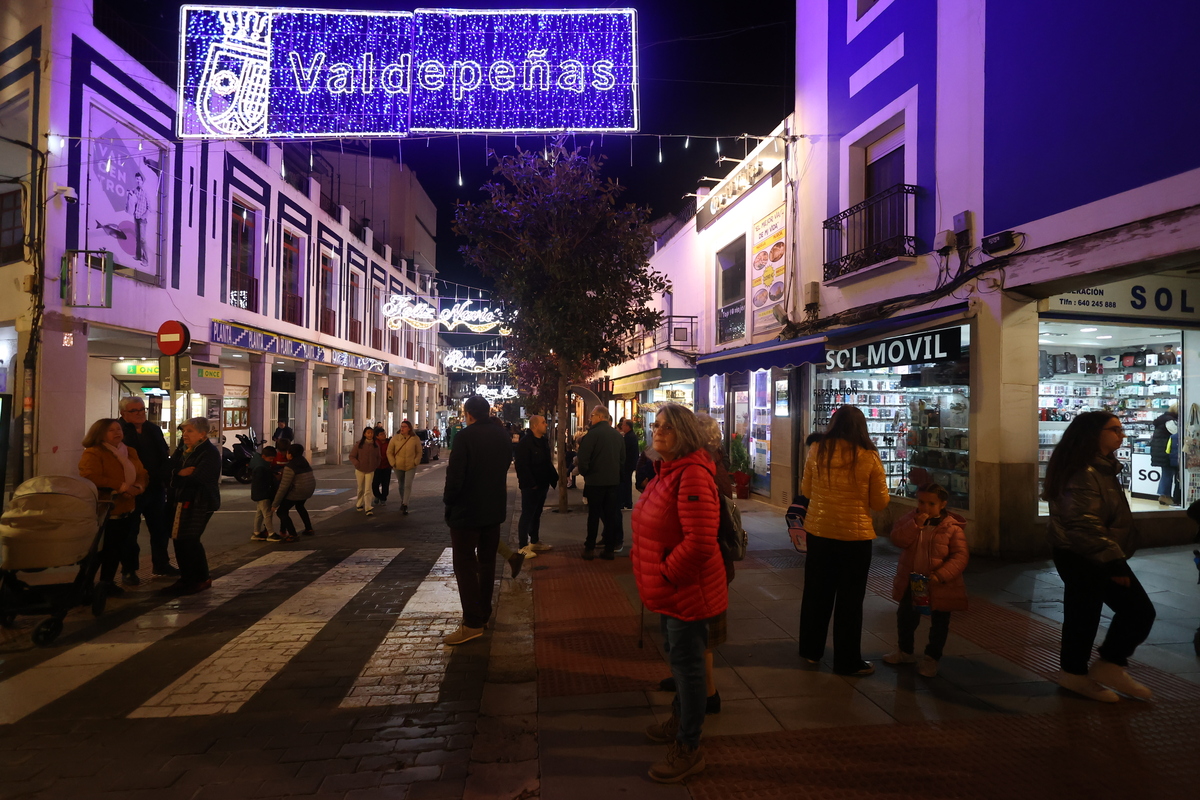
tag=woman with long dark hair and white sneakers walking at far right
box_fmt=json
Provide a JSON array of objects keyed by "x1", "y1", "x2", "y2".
[{"x1": 1042, "y1": 411, "x2": 1154, "y2": 703}]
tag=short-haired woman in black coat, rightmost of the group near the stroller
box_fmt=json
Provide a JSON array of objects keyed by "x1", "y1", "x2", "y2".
[{"x1": 163, "y1": 416, "x2": 221, "y2": 595}]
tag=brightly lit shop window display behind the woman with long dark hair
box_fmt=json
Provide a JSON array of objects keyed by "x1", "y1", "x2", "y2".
[{"x1": 1038, "y1": 362, "x2": 1183, "y2": 498}]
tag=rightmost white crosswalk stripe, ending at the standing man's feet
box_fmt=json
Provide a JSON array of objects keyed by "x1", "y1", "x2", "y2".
[{"x1": 341, "y1": 547, "x2": 461, "y2": 709}]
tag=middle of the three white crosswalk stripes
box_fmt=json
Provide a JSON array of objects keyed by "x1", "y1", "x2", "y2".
[{"x1": 130, "y1": 547, "x2": 403, "y2": 717}]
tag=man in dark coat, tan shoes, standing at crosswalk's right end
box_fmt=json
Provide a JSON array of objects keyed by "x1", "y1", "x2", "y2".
[{"x1": 442, "y1": 395, "x2": 512, "y2": 644}]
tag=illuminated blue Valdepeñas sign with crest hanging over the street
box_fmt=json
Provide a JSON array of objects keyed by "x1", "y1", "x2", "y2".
[{"x1": 178, "y1": 6, "x2": 637, "y2": 139}]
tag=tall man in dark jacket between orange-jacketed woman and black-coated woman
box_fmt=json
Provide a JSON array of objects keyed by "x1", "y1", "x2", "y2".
[{"x1": 119, "y1": 397, "x2": 179, "y2": 585}]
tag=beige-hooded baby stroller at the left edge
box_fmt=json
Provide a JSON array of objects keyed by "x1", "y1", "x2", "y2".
[{"x1": 0, "y1": 475, "x2": 112, "y2": 646}]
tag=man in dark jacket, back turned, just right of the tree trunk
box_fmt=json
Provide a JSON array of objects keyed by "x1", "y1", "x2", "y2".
[{"x1": 578, "y1": 405, "x2": 625, "y2": 561}]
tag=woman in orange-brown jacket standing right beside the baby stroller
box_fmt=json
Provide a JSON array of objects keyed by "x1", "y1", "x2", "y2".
[{"x1": 79, "y1": 419, "x2": 150, "y2": 596}]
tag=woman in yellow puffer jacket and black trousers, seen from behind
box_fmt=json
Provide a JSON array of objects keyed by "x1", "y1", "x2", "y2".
[{"x1": 800, "y1": 405, "x2": 888, "y2": 675}]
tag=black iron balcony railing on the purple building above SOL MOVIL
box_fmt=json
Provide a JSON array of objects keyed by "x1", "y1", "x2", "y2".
[{"x1": 823, "y1": 184, "x2": 917, "y2": 281}]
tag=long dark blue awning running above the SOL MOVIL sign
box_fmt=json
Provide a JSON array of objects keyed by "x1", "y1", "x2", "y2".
[{"x1": 696, "y1": 302, "x2": 970, "y2": 377}]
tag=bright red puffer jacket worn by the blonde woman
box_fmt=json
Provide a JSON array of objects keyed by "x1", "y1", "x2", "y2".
[{"x1": 630, "y1": 450, "x2": 728, "y2": 621}]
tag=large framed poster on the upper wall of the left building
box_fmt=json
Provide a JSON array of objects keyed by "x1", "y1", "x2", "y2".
[{"x1": 84, "y1": 107, "x2": 167, "y2": 276}]
